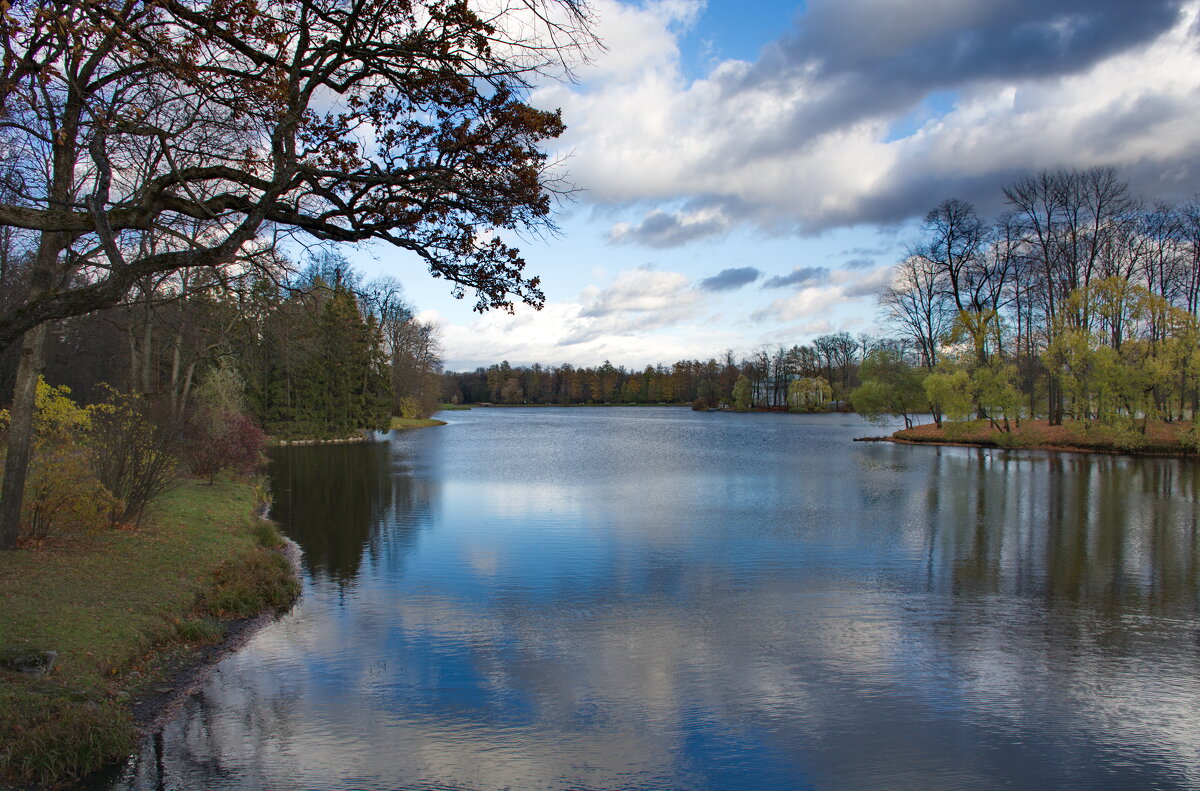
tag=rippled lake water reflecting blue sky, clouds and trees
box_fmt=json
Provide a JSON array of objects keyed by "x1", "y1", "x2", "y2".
[{"x1": 105, "y1": 408, "x2": 1200, "y2": 791}]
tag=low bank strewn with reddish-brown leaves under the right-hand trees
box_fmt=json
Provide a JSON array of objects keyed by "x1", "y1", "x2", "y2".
[{"x1": 892, "y1": 420, "x2": 1196, "y2": 455}]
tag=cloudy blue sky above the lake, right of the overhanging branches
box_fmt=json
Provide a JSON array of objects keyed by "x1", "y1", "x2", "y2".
[{"x1": 350, "y1": 0, "x2": 1200, "y2": 371}]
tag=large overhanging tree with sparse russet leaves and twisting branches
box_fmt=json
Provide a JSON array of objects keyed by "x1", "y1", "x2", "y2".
[{"x1": 0, "y1": 0, "x2": 588, "y2": 547}]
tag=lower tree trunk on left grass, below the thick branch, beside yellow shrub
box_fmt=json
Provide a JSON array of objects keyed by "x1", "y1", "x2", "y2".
[{"x1": 0, "y1": 324, "x2": 48, "y2": 550}]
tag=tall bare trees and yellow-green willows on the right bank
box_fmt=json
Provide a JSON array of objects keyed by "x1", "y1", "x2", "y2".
[{"x1": 856, "y1": 168, "x2": 1200, "y2": 443}]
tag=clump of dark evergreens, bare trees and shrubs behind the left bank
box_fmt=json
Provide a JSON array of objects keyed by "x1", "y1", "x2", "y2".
[{"x1": 0, "y1": 251, "x2": 451, "y2": 540}]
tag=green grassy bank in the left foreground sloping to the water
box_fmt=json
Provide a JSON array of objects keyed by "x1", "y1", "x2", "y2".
[{"x1": 0, "y1": 481, "x2": 299, "y2": 786}]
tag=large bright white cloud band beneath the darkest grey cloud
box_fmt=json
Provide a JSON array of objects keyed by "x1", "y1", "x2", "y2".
[{"x1": 538, "y1": 0, "x2": 1200, "y2": 238}]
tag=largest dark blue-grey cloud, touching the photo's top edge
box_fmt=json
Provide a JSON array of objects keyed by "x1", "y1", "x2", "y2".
[{"x1": 726, "y1": 0, "x2": 1182, "y2": 150}]
